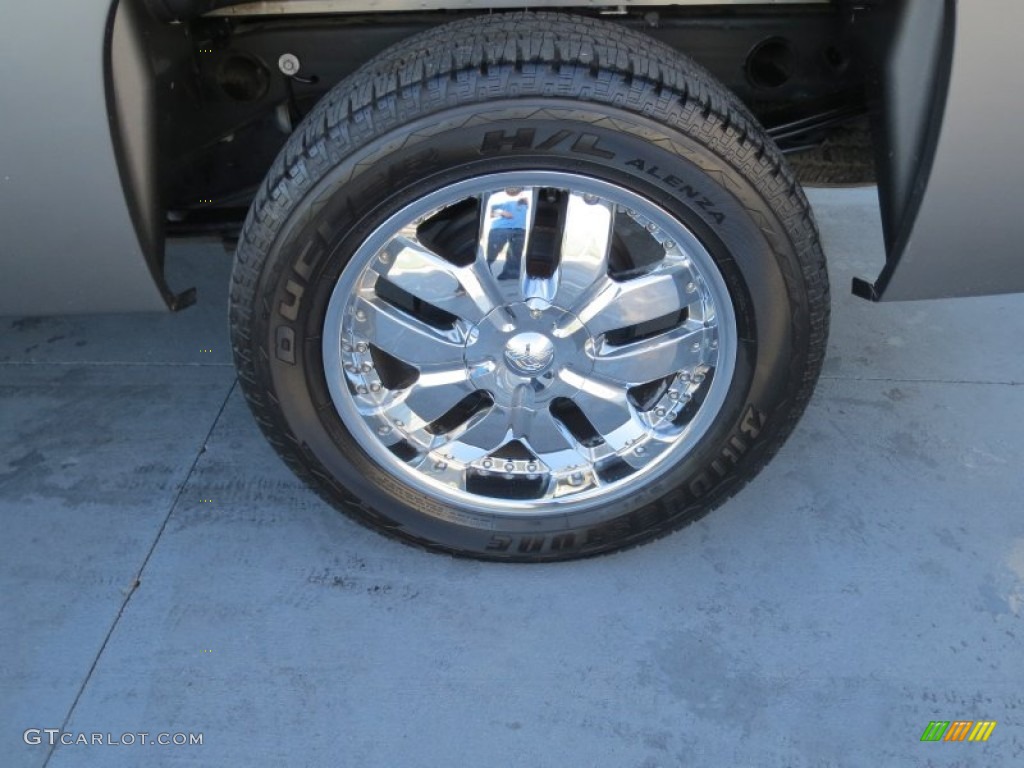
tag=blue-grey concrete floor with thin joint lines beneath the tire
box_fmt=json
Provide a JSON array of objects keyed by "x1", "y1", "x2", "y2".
[{"x1": 6, "y1": 188, "x2": 1024, "y2": 768}]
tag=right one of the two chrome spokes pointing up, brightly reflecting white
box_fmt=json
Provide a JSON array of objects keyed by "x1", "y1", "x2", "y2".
[{"x1": 543, "y1": 193, "x2": 615, "y2": 306}]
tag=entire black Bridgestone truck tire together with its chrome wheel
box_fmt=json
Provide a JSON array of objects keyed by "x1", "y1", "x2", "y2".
[{"x1": 230, "y1": 13, "x2": 828, "y2": 561}]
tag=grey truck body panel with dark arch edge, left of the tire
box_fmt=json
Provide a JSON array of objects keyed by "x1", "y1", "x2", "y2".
[{"x1": 0, "y1": 0, "x2": 180, "y2": 314}]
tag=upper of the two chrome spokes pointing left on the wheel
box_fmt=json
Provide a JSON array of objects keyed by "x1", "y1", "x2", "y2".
[{"x1": 374, "y1": 234, "x2": 501, "y2": 323}]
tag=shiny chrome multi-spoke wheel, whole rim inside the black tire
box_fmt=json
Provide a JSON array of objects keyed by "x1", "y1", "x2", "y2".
[{"x1": 323, "y1": 171, "x2": 737, "y2": 515}]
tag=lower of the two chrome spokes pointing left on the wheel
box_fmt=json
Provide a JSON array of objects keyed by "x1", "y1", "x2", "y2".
[{"x1": 355, "y1": 296, "x2": 463, "y2": 368}]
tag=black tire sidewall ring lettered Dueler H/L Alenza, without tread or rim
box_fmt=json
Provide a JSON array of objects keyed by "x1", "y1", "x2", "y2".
[{"x1": 245, "y1": 99, "x2": 808, "y2": 559}]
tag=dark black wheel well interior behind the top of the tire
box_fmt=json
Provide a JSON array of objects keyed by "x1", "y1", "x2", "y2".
[{"x1": 128, "y1": 0, "x2": 868, "y2": 238}]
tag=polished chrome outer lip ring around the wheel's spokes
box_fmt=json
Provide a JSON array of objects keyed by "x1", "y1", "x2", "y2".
[{"x1": 322, "y1": 171, "x2": 738, "y2": 518}]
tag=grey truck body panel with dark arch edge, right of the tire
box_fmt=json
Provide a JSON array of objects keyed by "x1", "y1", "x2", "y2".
[{"x1": 853, "y1": 0, "x2": 1024, "y2": 301}]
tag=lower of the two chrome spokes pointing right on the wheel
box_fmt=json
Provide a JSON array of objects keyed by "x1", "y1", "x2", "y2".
[{"x1": 593, "y1": 324, "x2": 712, "y2": 385}]
